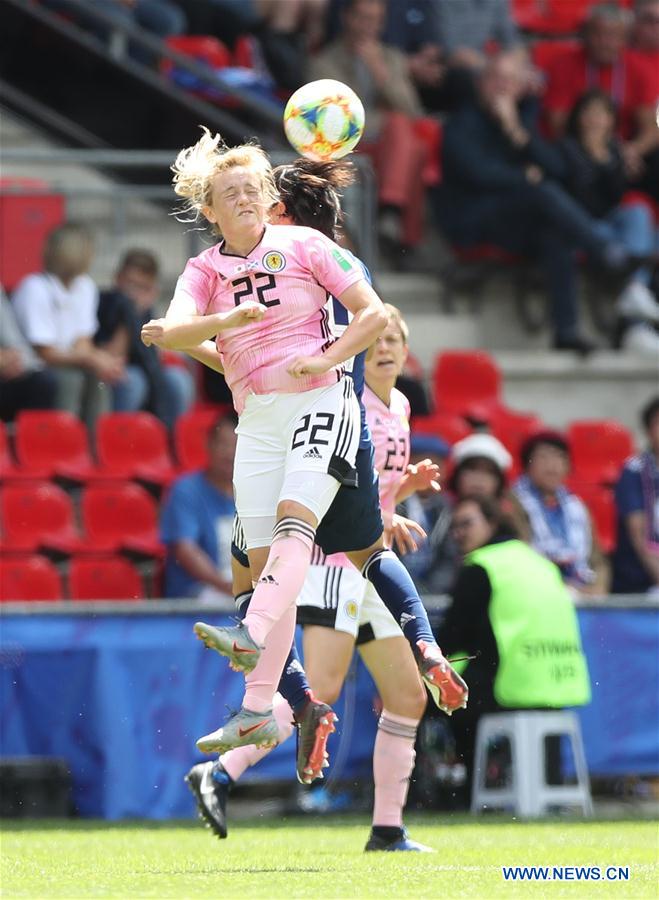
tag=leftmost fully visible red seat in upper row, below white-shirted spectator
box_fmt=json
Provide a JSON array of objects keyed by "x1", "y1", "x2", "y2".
[{"x1": 16, "y1": 410, "x2": 98, "y2": 482}]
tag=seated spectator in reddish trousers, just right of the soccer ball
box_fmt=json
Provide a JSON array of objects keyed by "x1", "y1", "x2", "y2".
[{"x1": 310, "y1": 0, "x2": 427, "y2": 250}]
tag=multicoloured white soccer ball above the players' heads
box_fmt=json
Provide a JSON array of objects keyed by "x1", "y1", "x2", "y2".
[{"x1": 284, "y1": 78, "x2": 364, "y2": 160}]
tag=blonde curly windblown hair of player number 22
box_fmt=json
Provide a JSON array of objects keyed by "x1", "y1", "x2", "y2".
[{"x1": 172, "y1": 126, "x2": 279, "y2": 231}]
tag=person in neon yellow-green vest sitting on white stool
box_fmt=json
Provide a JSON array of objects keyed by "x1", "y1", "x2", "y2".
[{"x1": 441, "y1": 497, "x2": 590, "y2": 799}]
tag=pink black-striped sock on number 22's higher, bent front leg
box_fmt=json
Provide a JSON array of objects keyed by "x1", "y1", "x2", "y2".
[{"x1": 244, "y1": 516, "x2": 316, "y2": 652}]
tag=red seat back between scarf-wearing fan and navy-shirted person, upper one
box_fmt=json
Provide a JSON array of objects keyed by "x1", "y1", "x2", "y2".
[{"x1": 568, "y1": 419, "x2": 634, "y2": 484}]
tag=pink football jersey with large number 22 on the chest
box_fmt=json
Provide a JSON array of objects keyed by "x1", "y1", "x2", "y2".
[{"x1": 175, "y1": 225, "x2": 364, "y2": 414}]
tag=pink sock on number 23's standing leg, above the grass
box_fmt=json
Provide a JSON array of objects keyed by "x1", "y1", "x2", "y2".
[{"x1": 373, "y1": 709, "x2": 419, "y2": 828}]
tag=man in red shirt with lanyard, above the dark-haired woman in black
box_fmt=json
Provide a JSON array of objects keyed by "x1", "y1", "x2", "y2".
[{"x1": 545, "y1": 3, "x2": 657, "y2": 186}]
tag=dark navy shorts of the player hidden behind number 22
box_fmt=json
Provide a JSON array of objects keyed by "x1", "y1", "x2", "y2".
[{"x1": 231, "y1": 446, "x2": 384, "y2": 568}]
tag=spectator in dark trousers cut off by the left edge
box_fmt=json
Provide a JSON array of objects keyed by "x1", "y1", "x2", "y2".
[{"x1": 0, "y1": 288, "x2": 57, "y2": 422}]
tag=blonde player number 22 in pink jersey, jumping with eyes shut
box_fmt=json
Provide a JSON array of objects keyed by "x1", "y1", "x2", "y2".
[{"x1": 142, "y1": 129, "x2": 386, "y2": 746}]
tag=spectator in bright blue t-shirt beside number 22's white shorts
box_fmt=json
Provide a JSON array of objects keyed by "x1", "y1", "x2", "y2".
[{"x1": 160, "y1": 413, "x2": 238, "y2": 599}]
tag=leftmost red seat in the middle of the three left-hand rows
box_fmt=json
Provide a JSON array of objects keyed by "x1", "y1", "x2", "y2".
[{"x1": 0, "y1": 481, "x2": 84, "y2": 555}]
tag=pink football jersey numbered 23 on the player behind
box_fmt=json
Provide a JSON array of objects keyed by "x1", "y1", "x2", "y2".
[{"x1": 362, "y1": 385, "x2": 410, "y2": 528}]
